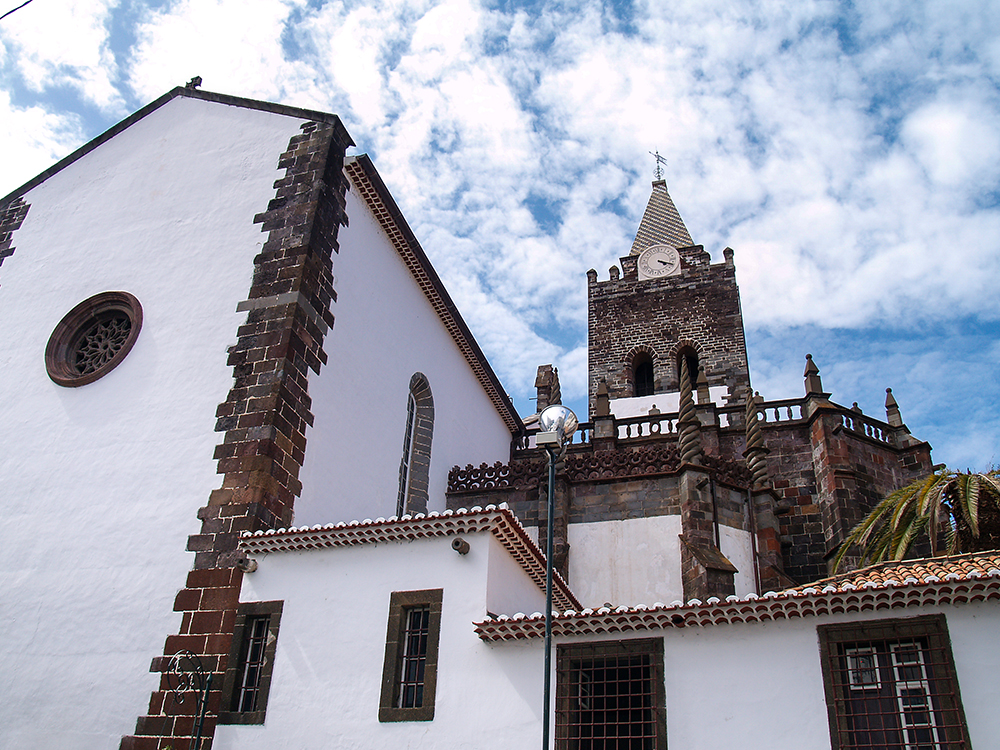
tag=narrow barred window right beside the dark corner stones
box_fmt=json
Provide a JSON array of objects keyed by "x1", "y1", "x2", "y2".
[{"x1": 219, "y1": 602, "x2": 282, "y2": 724}]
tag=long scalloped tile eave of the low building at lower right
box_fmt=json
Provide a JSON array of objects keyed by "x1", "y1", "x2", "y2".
[{"x1": 475, "y1": 553, "x2": 1000, "y2": 641}]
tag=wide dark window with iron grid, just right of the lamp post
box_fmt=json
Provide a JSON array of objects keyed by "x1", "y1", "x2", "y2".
[{"x1": 556, "y1": 638, "x2": 667, "y2": 750}]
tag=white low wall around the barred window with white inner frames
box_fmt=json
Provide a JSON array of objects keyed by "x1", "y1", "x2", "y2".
[{"x1": 664, "y1": 603, "x2": 1000, "y2": 750}]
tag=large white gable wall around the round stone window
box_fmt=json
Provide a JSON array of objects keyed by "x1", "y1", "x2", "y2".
[{"x1": 0, "y1": 97, "x2": 300, "y2": 750}]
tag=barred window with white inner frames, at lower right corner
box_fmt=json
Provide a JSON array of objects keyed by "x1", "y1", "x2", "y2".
[{"x1": 819, "y1": 615, "x2": 969, "y2": 750}]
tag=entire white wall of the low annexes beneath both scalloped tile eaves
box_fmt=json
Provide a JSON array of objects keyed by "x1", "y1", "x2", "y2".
[{"x1": 214, "y1": 533, "x2": 1000, "y2": 750}]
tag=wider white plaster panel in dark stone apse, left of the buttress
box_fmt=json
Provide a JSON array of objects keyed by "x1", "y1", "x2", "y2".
[{"x1": 569, "y1": 516, "x2": 683, "y2": 607}]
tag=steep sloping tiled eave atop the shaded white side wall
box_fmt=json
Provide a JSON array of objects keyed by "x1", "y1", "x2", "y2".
[{"x1": 344, "y1": 154, "x2": 524, "y2": 435}]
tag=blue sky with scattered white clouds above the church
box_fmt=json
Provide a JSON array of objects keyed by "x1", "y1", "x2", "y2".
[{"x1": 0, "y1": 0, "x2": 1000, "y2": 468}]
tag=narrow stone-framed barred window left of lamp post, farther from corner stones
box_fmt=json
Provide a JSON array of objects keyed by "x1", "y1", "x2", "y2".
[{"x1": 378, "y1": 589, "x2": 444, "y2": 721}]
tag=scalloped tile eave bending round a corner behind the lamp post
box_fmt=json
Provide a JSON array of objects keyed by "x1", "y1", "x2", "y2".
[{"x1": 240, "y1": 503, "x2": 580, "y2": 611}]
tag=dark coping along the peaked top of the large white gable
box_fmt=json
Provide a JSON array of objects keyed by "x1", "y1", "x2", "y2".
[{"x1": 0, "y1": 86, "x2": 354, "y2": 206}]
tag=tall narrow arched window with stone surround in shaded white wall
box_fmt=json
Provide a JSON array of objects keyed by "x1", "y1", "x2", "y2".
[{"x1": 396, "y1": 372, "x2": 434, "y2": 516}]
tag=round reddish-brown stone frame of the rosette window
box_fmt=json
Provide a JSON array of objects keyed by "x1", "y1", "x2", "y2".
[{"x1": 45, "y1": 292, "x2": 142, "y2": 388}]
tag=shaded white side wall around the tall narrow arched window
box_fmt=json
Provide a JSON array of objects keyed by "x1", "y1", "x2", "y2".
[{"x1": 295, "y1": 185, "x2": 511, "y2": 525}]
